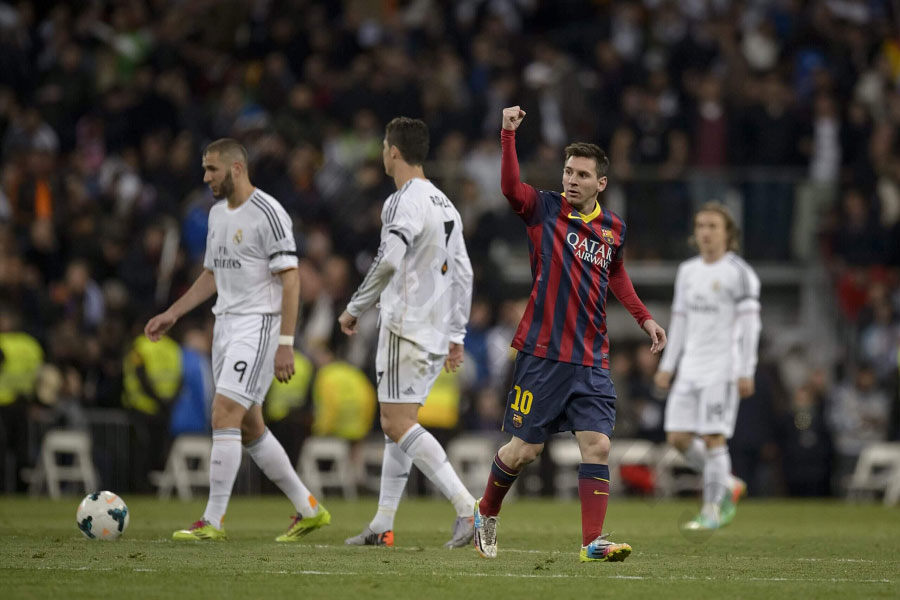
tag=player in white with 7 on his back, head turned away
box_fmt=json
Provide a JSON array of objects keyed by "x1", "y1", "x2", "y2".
[{"x1": 339, "y1": 117, "x2": 475, "y2": 548}]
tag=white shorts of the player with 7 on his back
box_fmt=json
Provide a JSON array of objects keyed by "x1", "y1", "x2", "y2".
[{"x1": 375, "y1": 324, "x2": 447, "y2": 404}]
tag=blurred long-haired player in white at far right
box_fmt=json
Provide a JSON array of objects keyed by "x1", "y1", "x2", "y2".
[{"x1": 655, "y1": 203, "x2": 761, "y2": 530}]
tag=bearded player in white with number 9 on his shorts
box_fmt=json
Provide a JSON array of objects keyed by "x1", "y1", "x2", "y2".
[{"x1": 144, "y1": 138, "x2": 331, "y2": 542}]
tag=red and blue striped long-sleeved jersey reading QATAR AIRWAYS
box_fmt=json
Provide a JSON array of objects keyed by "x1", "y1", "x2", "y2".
[{"x1": 501, "y1": 130, "x2": 651, "y2": 369}]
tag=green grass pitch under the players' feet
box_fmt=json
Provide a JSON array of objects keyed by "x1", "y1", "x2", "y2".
[{"x1": 0, "y1": 496, "x2": 900, "y2": 600}]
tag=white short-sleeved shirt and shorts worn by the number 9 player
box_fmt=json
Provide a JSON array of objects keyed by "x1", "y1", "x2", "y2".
[{"x1": 203, "y1": 189, "x2": 297, "y2": 409}]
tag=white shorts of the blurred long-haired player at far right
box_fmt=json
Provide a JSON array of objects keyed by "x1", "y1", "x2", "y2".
[{"x1": 665, "y1": 377, "x2": 738, "y2": 438}]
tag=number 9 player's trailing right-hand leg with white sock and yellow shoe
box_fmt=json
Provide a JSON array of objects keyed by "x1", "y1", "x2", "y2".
[{"x1": 241, "y1": 404, "x2": 331, "y2": 542}]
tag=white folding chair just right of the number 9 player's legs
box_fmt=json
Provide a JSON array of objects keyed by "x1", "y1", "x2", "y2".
[{"x1": 297, "y1": 437, "x2": 356, "y2": 500}]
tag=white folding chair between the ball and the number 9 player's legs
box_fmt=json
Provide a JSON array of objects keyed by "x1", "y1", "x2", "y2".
[{"x1": 150, "y1": 434, "x2": 212, "y2": 502}]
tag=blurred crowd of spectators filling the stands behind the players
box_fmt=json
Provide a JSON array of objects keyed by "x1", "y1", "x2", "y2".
[{"x1": 0, "y1": 0, "x2": 900, "y2": 495}]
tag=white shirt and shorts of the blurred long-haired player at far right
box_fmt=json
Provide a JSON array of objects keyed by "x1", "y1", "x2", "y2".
[{"x1": 659, "y1": 252, "x2": 760, "y2": 437}]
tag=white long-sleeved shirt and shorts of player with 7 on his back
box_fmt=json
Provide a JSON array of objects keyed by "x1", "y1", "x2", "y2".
[{"x1": 347, "y1": 178, "x2": 472, "y2": 403}]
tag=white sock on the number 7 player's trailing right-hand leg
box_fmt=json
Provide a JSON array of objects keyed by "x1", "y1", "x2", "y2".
[{"x1": 397, "y1": 423, "x2": 475, "y2": 517}]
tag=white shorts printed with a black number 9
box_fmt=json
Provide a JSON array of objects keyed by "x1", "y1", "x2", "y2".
[{"x1": 213, "y1": 315, "x2": 281, "y2": 410}]
